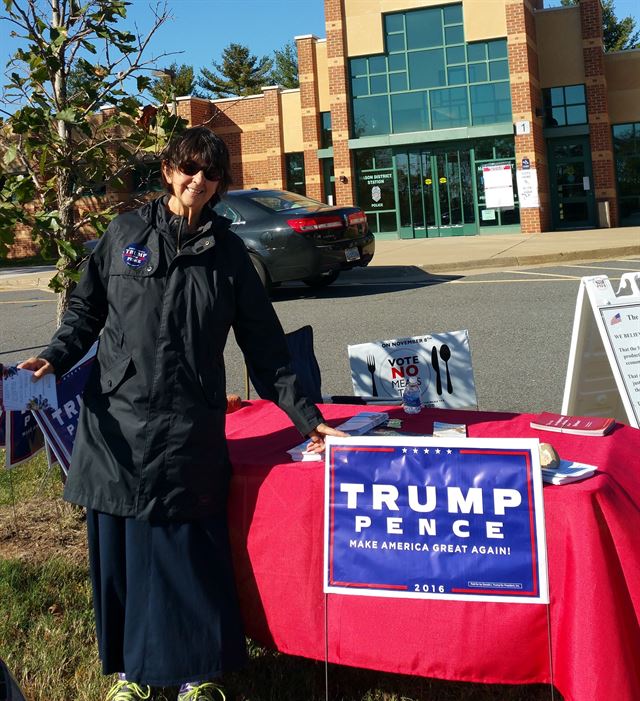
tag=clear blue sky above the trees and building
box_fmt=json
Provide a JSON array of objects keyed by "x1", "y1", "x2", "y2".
[{"x1": 0, "y1": 0, "x2": 640, "y2": 90}]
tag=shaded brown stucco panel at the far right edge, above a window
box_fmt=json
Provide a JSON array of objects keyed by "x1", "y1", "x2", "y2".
[{"x1": 604, "y1": 49, "x2": 640, "y2": 124}]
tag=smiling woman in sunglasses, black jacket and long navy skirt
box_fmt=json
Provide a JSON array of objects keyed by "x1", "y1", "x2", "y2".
[{"x1": 21, "y1": 127, "x2": 343, "y2": 701}]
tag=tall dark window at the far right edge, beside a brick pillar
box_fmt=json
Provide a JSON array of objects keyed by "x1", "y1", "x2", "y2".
[{"x1": 613, "y1": 122, "x2": 640, "y2": 226}]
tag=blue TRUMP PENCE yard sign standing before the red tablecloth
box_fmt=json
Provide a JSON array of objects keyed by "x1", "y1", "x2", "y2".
[{"x1": 324, "y1": 436, "x2": 549, "y2": 603}]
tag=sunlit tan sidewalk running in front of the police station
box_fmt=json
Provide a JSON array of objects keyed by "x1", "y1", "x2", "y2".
[{"x1": 0, "y1": 226, "x2": 640, "y2": 292}]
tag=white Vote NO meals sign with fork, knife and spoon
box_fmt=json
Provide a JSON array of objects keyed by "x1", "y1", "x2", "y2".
[{"x1": 348, "y1": 330, "x2": 478, "y2": 409}]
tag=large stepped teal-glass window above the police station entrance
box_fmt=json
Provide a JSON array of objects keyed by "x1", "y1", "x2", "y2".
[{"x1": 349, "y1": 4, "x2": 512, "y2": 137}]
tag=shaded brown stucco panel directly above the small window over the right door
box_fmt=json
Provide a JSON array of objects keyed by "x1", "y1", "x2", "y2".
[{"x1": 535, "y1": 7, "x2": 585, "y2": 88}]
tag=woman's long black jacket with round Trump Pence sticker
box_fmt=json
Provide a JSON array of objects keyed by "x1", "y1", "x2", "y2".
[{"x1": 41, "y1": 198, "x2": 322, "y2": 521}]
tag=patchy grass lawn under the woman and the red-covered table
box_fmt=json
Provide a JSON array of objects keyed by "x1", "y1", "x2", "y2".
[{"x1": 0, "y1": 451, "x2": 562, "y2": 701}]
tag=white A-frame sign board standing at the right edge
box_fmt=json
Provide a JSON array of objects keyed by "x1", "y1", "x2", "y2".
[{"x1": 562, "y1": 272, "x2": 640, "y2": 428}]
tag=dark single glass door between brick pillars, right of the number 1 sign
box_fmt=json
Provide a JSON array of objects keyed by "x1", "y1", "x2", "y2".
[{"x1": 547, "y1": 136, "x2": 596, "y2": 229}]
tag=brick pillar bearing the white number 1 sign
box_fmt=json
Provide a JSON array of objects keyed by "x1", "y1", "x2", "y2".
[{"x1": 505, "y1": 0, "x2": 551, "y2": 234}]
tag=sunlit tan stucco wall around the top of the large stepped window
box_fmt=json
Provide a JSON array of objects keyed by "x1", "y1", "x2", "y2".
[{"x1": 344, "y1": 0, "x2": 507, "y2": 57}]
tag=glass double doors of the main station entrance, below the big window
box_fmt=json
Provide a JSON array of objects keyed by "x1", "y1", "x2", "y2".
[{"x1": 396, "y1": 149, "x2": 476, "y2": 238}]
